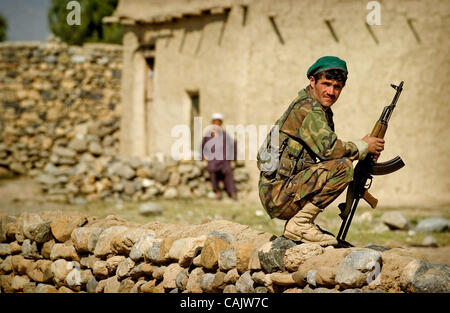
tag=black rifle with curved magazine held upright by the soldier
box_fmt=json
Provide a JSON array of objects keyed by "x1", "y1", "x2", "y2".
[{"x1": 336, "y1": 81, "x2": 405, "y2": 242}]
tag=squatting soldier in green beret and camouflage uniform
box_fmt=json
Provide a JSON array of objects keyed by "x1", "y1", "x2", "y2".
[{"x1": 258, "y1": 56, "x2": 384, "y2": 246}]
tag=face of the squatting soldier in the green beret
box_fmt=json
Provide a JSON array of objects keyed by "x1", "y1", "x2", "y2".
[{"x1": 309, "y1": 76, "x2": 344, "y2": 108}]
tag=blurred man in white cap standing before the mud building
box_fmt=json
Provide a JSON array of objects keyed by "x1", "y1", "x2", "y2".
[{"x1": 202, "y1": 113, "x2": 237, "y2": 200}]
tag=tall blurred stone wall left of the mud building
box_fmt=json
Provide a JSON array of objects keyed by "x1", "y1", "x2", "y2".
[{"x1": 0, "y1": 41, "x2": 122, "y2": 176}]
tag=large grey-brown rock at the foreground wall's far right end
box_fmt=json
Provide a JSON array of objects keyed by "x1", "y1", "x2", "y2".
[{"x1": 400, "y1": 260, "x2": 450, "y2": 293}]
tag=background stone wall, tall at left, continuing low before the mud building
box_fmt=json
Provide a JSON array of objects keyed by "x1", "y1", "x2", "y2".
[{"x1": 0, "y1": 40, "x2": 249, "y2": 203}]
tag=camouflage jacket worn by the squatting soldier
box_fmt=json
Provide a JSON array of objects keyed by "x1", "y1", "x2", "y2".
[{"x1": 258, "y1": 85, "x2": 367, "y2": 180}]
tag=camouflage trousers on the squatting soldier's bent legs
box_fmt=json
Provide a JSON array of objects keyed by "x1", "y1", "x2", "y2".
[{"x1": 259, "y1": 158, "x2": 353, "y2": 219}]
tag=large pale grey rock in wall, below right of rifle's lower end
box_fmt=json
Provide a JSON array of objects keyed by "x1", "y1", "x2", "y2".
[{"x1": 336, "y1": 249, "x2": 381, "y2": 288}]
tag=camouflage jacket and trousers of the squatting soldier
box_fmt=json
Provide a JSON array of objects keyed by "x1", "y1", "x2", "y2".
[{"x1": 258, "y1": 86, "x2": 367, "y2": 219}]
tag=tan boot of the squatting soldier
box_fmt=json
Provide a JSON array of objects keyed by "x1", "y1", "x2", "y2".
[{"x1": 283, "y1": 203, "x2": 338, "y2": 246}]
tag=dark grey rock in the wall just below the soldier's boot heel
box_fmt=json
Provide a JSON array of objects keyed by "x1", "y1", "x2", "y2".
[{"x1": 258, "y1": 237, "x2": 295, "y2": 273}]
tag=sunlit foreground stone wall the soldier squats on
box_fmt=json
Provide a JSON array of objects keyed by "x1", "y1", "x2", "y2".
[{"x1": 0, "y1": 212, "x2": 450, "y2": 293}]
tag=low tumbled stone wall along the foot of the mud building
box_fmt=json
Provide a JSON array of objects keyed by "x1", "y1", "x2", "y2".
[{"x1": 36, "y1": 155, "x2": 250, "y2": 204}]
